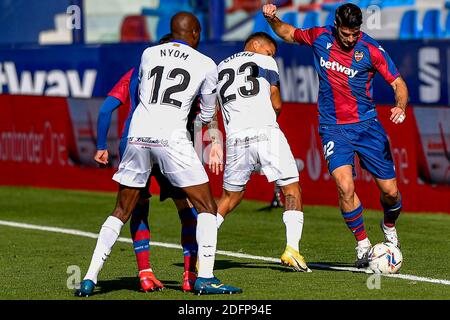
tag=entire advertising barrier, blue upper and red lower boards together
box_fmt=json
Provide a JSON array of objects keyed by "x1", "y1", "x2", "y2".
[{"x1": 0, "y1": 41, "x2": 450, "y2": 212}]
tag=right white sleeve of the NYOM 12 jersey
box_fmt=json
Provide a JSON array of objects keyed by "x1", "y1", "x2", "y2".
[{"x1": 200, "y1": 60, "x2": 219, "y2": 124}]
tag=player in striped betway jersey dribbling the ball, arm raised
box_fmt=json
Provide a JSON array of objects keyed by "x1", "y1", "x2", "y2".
[{"x1": 263, "y1": 3, "x2": 408, "y2": 267}]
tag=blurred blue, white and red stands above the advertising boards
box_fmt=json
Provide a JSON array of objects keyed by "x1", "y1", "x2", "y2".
[{"x1": 0, "y1": 0, "x2": 450, "y2": 45}]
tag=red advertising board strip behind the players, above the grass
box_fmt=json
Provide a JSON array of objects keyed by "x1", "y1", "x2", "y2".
[{"x1": 0, "y1": 95, "x2": 450, "y2": 213}]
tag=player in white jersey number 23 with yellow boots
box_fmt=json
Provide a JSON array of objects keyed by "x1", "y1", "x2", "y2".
[{"x1": 212, "y1": 32, "x2": 310, "y2": 272}]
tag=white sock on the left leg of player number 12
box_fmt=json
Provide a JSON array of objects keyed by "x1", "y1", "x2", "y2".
[{"x1": 84, "y1": 216, "x2": 123, "y2": 284}]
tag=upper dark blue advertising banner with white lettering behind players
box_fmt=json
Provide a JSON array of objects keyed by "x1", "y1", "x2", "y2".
[{"x1": 0, "y1": 41, "x2": 450, "y2": 106}]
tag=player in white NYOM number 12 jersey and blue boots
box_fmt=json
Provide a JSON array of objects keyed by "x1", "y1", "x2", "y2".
[{"x1": 76, "y1": 12, "x2": 242, "y2": 296}]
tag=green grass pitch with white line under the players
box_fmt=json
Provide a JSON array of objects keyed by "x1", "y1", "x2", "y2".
[{"x1": 0, "y1": 187, "x2": 450, "y2": 300}]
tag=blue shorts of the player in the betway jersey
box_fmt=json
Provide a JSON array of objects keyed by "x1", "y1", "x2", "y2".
[{"x1": 319, "y1": 118, "x2": 395, "y2": 179}]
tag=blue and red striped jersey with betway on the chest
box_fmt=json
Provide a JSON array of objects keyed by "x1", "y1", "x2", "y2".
[{"x1": 294, "y1": 26, "x2": 399, "y2": 124}]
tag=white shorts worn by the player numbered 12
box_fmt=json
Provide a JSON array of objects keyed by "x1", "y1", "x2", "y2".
[{"x1": 113, "y1": 137, "x2": 209, "y2": 188}]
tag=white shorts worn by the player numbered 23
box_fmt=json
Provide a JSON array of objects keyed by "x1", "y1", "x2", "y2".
[{"x1": 223, "y1": 127, "x2": 299, "y2": 192}]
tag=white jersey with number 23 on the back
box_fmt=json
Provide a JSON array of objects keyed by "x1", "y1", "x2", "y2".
[{"x1": 217, "y1": 51, "x2": 280, "y2": 135}]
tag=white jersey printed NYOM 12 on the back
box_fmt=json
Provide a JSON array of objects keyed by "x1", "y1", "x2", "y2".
[{"x1": 128, "y1": 42, "x2": 217, "y2": 139}]
